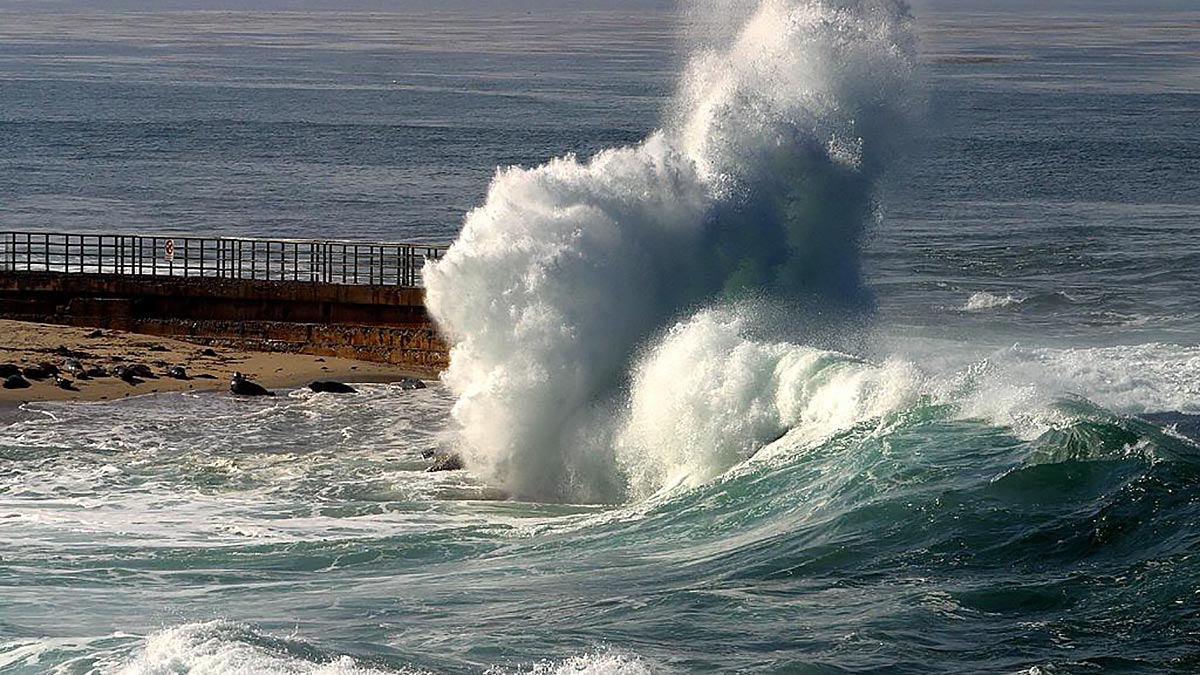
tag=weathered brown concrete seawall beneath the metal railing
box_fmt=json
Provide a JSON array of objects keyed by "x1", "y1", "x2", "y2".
[{"x1": 0, "y1": 271, "x2": 448, "y2": 371}]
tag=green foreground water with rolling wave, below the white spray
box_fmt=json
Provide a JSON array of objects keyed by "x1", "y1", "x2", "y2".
[{"x1": 7, "y1": 387, "x2": 1200, "y2": 674}]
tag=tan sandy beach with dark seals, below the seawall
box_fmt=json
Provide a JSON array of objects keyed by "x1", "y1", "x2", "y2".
[{"x1": 0, "y1": 319, "x2": 427, "y2": 406}]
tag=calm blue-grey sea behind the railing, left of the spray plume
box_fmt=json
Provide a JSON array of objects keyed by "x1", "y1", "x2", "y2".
[{"x1": 0, "y1": 13, "x2": 674, "y2": 241}]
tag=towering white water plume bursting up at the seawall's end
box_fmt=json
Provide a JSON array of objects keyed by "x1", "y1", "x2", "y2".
[{"x1": 425, "y1": 0, "x2": 913, "y2": 501}]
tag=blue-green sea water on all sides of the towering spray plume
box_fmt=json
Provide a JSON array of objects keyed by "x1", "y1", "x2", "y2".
[{"x1": 0, "y1": 5, "x2": 1200, "y2": 675}]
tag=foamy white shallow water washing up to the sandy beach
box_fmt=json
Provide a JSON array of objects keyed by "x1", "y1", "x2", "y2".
[{"x1": 0, "y1": 384, "x2": 491, "y2": 556}]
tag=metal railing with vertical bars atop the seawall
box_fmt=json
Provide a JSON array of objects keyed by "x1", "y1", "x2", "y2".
[{"x1": 0, "y1": 232, "x2": 446, "y2": 287}]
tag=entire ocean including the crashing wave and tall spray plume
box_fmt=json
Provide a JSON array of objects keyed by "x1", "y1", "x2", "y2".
[{"x1": 0, "y1": 0, "x2": 1200, "y2": 675}]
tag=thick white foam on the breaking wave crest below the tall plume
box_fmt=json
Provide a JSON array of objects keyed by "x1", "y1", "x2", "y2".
[{"x1": 617, "y1": 311, "x2": 922, "y2": 496}]
